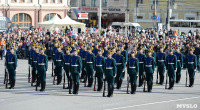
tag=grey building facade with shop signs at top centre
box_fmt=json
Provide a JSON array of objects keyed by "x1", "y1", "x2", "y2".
[{"x1": 71, "y1": 0, "x2": 127, "y2": 28}]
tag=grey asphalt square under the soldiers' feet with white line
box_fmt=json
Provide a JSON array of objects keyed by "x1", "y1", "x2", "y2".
[{"x1": 0, "y1": 60, "x2": 200, "y2": 110}]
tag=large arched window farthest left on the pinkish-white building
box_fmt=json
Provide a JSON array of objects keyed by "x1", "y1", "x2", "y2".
[{"x1": 12, "y1": 13, "x2": 32, "y2": 28}]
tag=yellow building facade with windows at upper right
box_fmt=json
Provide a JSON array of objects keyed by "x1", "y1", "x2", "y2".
[{"x1": 127, "y1": 0, "x2": 200, "y2": 28}]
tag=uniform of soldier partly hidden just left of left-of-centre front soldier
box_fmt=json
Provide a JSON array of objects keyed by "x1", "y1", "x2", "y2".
[{"x1": 63, "y1": 54, "x2": 72, "y2": 88}]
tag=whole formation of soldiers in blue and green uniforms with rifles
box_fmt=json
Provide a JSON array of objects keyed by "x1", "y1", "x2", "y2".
[{"x1": 1, "y1": 35, "x2": 197, "y2": 97}]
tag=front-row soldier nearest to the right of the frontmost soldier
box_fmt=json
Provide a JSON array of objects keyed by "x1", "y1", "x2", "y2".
[{"x1": 127, "y1": 51, "x2": 139, "y2": 94}]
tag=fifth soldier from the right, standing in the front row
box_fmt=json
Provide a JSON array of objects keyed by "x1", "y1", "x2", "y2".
[{"x1": 144, "y1": 49, "x2": 155, "y2": 92}]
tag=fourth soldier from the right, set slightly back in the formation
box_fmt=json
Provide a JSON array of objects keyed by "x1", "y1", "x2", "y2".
[{"x1": 156, "y1": 46, "x2": 166, "y2": 85}]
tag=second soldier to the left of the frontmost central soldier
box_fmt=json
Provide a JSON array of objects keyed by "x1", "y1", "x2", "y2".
[{"x1": 85, "y1": 46, "x2": 95, "y2": 87}]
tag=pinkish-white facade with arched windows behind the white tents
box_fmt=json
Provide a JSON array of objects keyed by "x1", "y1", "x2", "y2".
[{"x1": 0, "y1": 0, "x2": 70, "y2": 28}]
